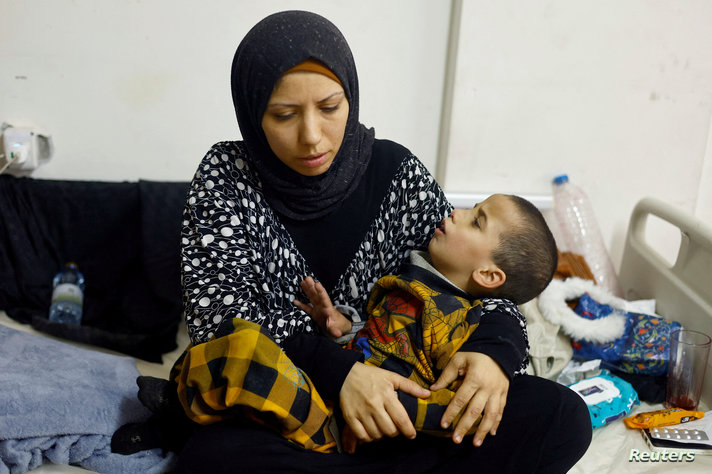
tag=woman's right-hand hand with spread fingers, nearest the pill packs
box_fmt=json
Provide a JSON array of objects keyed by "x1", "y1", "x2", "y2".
[{"x1": 430, "y1": 352, "x2": 509, "y2": 446}]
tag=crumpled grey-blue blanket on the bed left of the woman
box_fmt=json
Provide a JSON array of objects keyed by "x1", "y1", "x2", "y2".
[{"x1": 0, "y1": 325, "x2": 174, "y2": 474}]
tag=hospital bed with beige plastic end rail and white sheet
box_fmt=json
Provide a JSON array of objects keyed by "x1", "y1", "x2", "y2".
[{"x1": 0, "y1": 194, "x2": 712, "y2": 474}]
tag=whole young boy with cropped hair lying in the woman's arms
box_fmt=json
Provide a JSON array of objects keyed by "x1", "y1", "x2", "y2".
[{"x1": 171, "y1": 194, "x2": 557, "y2": 452}]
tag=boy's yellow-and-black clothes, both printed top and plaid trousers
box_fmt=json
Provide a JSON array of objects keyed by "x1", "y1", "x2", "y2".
[{"x1": 171, "y1": 275, "x2": 482, "y2": 452}]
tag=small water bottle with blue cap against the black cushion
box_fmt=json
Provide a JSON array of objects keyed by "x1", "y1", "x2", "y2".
[{"x1": 49, "y1": 262, "x2": 84, "y2": 324}]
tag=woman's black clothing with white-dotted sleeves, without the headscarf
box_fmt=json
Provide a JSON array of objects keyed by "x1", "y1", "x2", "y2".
[{"x1": 178, "y1": 140, "x2": 591, "y2": 473}]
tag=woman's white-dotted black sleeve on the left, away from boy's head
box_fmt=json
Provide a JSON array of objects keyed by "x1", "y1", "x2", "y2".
[{"x1": 181, "y1": 142, "x2": 316, "y2": 343}]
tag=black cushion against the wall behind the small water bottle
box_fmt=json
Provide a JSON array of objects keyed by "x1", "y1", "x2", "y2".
[{"x1": 0, "y1": 176, "x2": 188, "y2": 361}]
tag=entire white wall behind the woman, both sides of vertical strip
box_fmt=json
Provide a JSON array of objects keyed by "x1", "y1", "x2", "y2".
[{"x1": 0, "y1": 0, "x2": 712, "y2": 272}]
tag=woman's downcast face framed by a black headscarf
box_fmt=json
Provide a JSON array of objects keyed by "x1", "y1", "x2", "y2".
[{"x1": 262, "y1": 71, "x2": 349, "y2": 176}]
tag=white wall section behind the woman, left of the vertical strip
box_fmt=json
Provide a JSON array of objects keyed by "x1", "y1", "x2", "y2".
[{"x1": 0, "y1": 0, "x2": 449, "y2": 180}]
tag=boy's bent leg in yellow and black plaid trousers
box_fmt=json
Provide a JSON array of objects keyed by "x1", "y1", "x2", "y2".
[{"x1": 171, "y1": 318, "x2": 336, "y2": 452}]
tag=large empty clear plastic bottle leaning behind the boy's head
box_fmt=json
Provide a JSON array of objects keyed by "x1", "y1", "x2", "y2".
[{"x1": 554, "y1": 174, "x2": 623, "y2": 297}]
